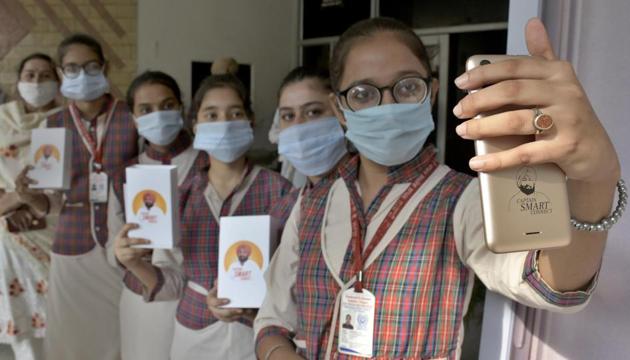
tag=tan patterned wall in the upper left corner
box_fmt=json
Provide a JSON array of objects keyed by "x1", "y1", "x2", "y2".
[{"x1": 0, "y1": 0, "x2": 137, "y2": 100}]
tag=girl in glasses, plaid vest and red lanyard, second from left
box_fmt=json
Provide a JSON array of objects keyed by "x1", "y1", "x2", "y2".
[{"x1": 16, "y1": 34, "x2": 138, "y2": 360}]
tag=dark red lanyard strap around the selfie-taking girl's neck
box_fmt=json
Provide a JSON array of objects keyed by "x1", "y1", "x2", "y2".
[{"x1": 350, "y1": 161, "x2": 438, "y2": 292}]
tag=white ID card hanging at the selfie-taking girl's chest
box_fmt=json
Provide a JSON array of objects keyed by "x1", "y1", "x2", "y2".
[{"x1": 338, "y1": 288, "x2": 376, "y2": 358}]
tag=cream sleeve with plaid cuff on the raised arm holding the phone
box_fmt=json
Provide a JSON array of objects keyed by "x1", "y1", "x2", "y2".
[{"x1": 453, "y1": 179, "x2": 597, "y2": 313}]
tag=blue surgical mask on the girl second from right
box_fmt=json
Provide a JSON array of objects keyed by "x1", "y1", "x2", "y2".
[{"x1": 278, "y1": 117, "x2": 347, "y2": 176}]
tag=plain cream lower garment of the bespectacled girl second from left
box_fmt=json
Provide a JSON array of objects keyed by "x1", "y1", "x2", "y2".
[{"x1": 45, "y1": 248, "x2": 122, "y2": 360}]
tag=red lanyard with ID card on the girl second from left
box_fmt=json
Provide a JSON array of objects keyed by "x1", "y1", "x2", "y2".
[{"x1": 69, "y1": 100, "x2": 117, "y2": 203}]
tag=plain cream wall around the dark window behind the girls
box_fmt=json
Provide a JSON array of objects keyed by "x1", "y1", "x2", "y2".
[{"x1": 138, "y1": 0, "x2": 298, "y2": 148}]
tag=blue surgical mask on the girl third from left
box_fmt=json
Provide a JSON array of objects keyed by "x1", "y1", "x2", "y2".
[{"x1": 136, "y1": 110, "x2": 184, "y2": 146}]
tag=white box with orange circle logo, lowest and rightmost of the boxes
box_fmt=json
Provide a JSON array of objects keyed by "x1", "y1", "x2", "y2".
[{"x1": 218, "y1": 215, "x2": 278, "y2": 308}]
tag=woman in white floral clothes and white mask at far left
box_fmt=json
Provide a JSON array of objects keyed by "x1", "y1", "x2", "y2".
[{"x1": 0, "y1": 53, "x2": 60, "y2": 360}]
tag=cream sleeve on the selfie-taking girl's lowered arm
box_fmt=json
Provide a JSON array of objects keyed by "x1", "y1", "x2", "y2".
[{"x1": 254, "y1": 196, "x2": 302, "y2": 340}]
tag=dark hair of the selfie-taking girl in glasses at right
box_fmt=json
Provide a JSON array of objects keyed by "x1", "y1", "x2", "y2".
[{"x1": 330, "y1": 17, "x2": 431, "y2": 90}]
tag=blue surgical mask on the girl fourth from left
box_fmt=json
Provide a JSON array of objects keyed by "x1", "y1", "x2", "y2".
[{"x1": 193, "y1": 120, "x2": 254, "y2": 163}]
